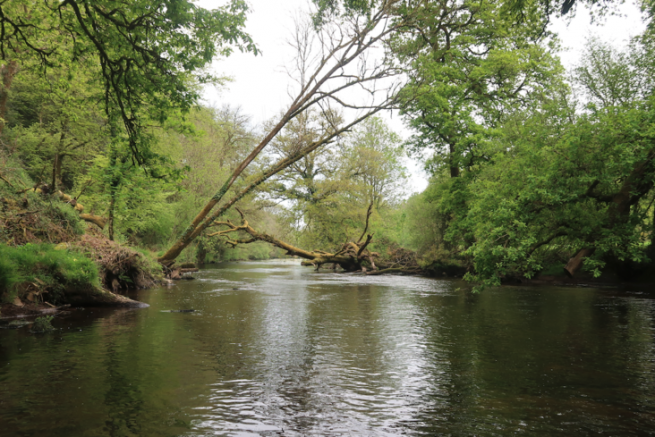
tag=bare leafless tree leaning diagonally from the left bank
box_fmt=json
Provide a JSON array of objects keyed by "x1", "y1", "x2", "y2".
[{"x1": 159, "y1": 0, "x2": 406, "y2": 266}]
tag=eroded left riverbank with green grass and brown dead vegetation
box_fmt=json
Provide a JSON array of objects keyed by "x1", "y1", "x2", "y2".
[{"x1": 0, "y1": 233, "x2": 164, "y2": 317}]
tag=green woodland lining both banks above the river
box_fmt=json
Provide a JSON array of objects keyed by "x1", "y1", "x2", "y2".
[{"x1": 0, "y1": 0, "x2": 655, "y2": 306}]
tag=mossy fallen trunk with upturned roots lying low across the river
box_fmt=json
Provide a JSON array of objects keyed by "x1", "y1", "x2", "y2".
[{"x1": 208, "y1": 205, "x2": 423, "y2": 275}]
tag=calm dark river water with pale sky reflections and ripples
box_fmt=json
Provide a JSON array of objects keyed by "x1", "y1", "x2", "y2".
[{"x1": 0, "y1": 261, "x2": 655, "y2": 437}]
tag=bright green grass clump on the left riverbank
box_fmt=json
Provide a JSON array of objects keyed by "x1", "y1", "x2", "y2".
[{"x1": 0, "y1": 243, "x2": 100, "y2": 304}]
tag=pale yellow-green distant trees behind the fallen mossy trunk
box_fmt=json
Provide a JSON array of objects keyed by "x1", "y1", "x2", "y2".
[{"x1": 264, "y1": 116, "x2": 406, "y2": 250}]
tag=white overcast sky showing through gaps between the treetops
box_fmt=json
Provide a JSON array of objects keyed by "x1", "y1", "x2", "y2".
[{"x1": 198, "y1": 0, "x2": 645, "y2": 194}]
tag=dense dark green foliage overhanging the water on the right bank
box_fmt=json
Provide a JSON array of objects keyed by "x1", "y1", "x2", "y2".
[{"x1": 469, "y1": 94, "x2": 655, "y2": 282}]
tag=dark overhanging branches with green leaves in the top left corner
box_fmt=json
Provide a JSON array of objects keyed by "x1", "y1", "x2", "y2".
[{"x1": 0, "y1": 0, "x2": 257, "y2": 164}]
